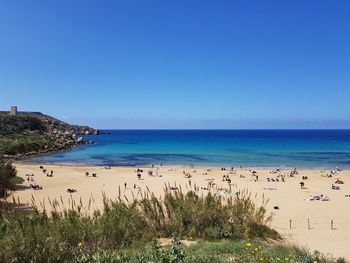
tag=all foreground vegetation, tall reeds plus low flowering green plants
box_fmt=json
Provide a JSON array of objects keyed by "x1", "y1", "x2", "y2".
[{"x1": 0, "y1": 187, "x2": 343, "y2": 263}]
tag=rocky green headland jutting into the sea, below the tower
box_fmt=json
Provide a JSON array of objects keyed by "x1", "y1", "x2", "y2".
[{"x1": 0, "y1": 113, "x2": 99, "y2": 158}]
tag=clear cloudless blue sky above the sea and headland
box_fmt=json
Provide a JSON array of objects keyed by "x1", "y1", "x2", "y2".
[{"x1": 0, "y1": 0, "x2": 350, "y2": 128}]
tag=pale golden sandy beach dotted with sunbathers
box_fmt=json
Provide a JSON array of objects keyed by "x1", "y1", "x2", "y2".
[{"x1": 8, "y1": 163, "x2": 350, "y2": 259}]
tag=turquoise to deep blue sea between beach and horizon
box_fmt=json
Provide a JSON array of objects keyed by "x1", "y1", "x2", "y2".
[{"x1": 29, "y1": 130, "x2": 350, "y2": 168}]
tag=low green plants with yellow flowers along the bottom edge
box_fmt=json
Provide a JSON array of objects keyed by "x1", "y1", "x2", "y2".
[{"x1": 74, "y1": 238, "x2": 345, "y2": 263}]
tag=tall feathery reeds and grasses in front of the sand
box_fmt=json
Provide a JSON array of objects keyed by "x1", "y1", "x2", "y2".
[{"x1": 0, "y1": 188, "x2": 279, "y2": 262}]
